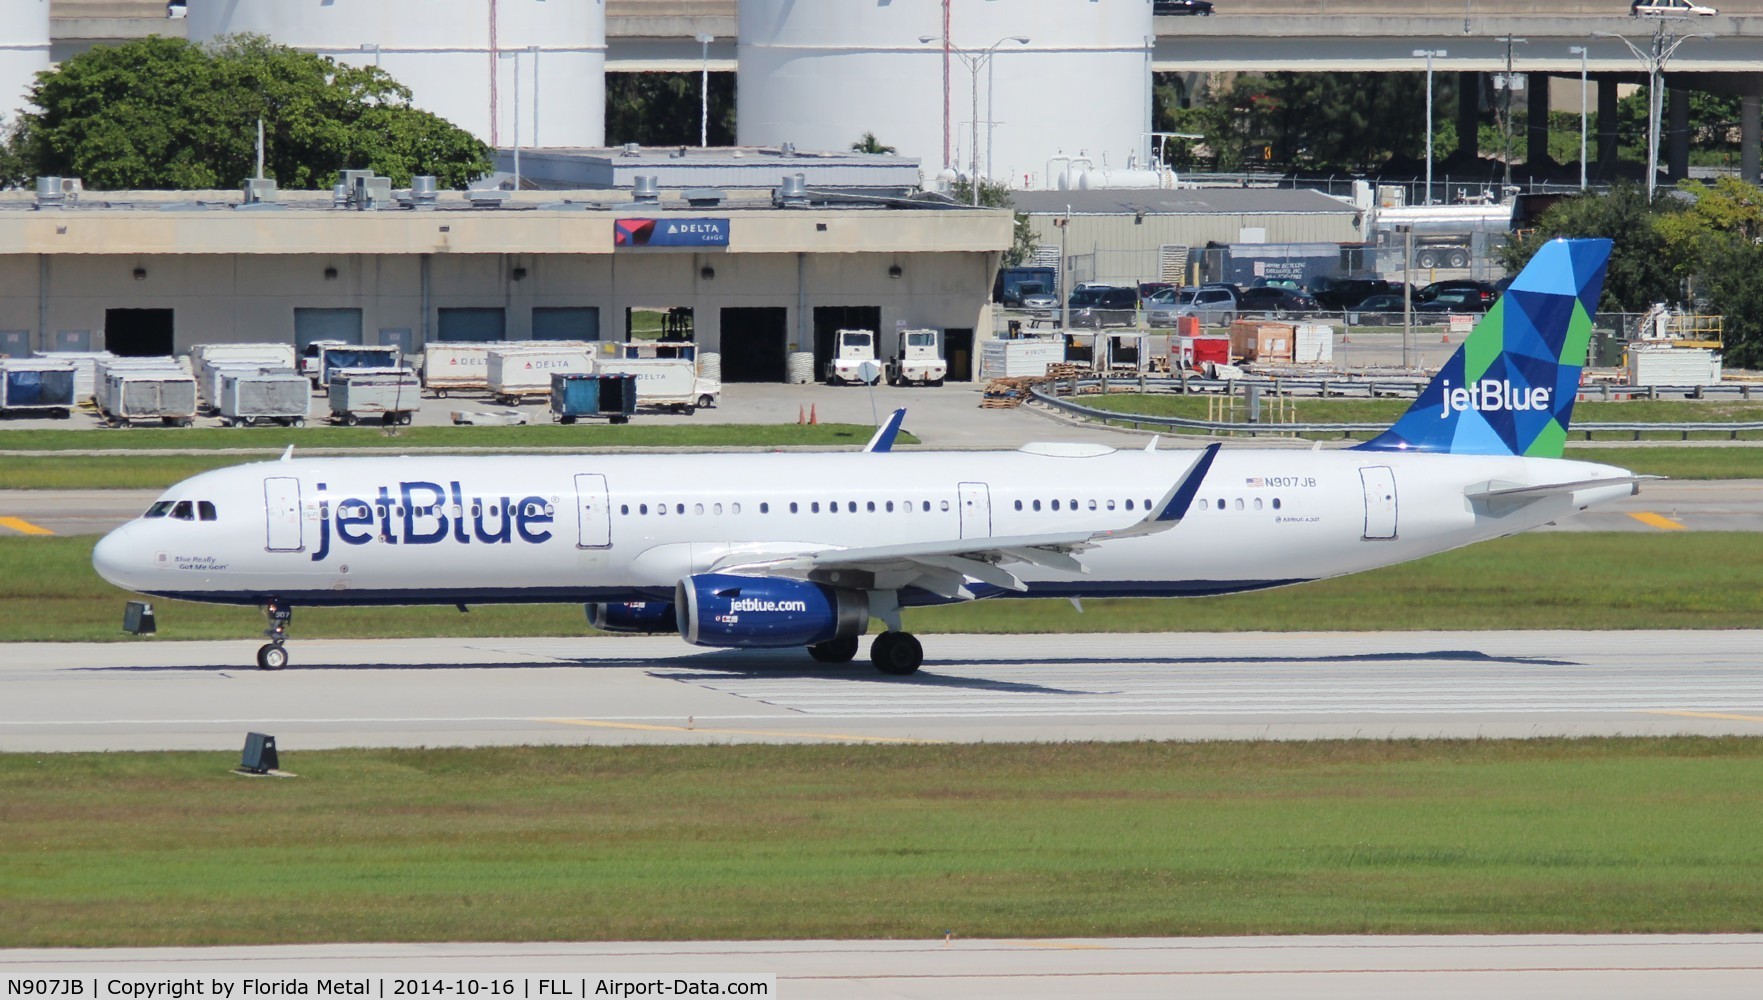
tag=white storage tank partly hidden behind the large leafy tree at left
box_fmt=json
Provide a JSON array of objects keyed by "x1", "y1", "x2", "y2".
[{"x1": 189, "y1": 0, "x2": 606, "y2": 146}]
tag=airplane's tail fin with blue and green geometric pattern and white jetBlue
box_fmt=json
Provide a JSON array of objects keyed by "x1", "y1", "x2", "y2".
[{"x1": 1359, "y1": 240, "x2": 1610, "y2": 459}]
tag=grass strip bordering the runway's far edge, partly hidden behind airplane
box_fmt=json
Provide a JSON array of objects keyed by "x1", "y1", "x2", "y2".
[{"x1": 13, "y1": 533, "x2": 1763, "y2": 644}]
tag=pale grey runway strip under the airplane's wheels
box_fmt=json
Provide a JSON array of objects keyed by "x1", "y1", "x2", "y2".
[{"x1": 0, "y1": 631, "x2": 1763, "y2": 760}]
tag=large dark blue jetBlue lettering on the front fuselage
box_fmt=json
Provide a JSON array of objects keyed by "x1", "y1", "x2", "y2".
[{"x1": 312, "y1": 480, "x2": 555, "y2": 563}]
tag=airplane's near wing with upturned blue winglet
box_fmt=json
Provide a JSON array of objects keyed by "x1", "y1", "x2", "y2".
[{"x1": 714, "y1": 444, "x2": 1218, "y2": 600}]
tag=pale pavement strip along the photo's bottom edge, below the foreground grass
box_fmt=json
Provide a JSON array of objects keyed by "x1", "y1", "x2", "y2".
[{"x1": 0, "y1": 935, "x2": 1763, "y2": 1000}]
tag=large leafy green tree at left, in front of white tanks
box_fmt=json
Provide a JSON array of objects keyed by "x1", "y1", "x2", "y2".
[{"x1": 9, "y1": 35, "x2": 490, "y2": 190}]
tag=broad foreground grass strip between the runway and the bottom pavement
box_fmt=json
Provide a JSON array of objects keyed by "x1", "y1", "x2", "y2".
[{"x1": 0, "y1": 737, "x2": 1763, "y2": 947}]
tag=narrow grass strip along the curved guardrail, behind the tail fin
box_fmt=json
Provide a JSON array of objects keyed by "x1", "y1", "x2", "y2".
[{"x1": 1075, "y1": 393, "x2": 1763, "y2": 441}]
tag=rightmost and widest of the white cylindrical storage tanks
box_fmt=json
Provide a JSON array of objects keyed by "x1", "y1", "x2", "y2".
[{"x1": 737, "y1": 0, "x2": 1155, "y2": 187}]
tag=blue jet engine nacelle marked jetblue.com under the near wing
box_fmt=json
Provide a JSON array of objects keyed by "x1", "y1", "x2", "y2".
[{"x1": 673, "y1": 573, "x2": 869, "y2": 649}]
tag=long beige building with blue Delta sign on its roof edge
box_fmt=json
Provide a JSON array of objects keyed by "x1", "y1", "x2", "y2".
[{"x1": 0, "y1": 171, "x2": 1012, "y2": 381}]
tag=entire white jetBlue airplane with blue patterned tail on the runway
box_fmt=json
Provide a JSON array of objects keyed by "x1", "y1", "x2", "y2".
[{"x1": 92, "y1": 240, "x2": 1640, "y2": 674}]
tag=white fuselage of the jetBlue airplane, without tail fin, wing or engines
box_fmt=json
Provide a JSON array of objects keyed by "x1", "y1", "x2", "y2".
[{"x1": 93, "y1": 446, "x2": 1633, "y2": 605}]
